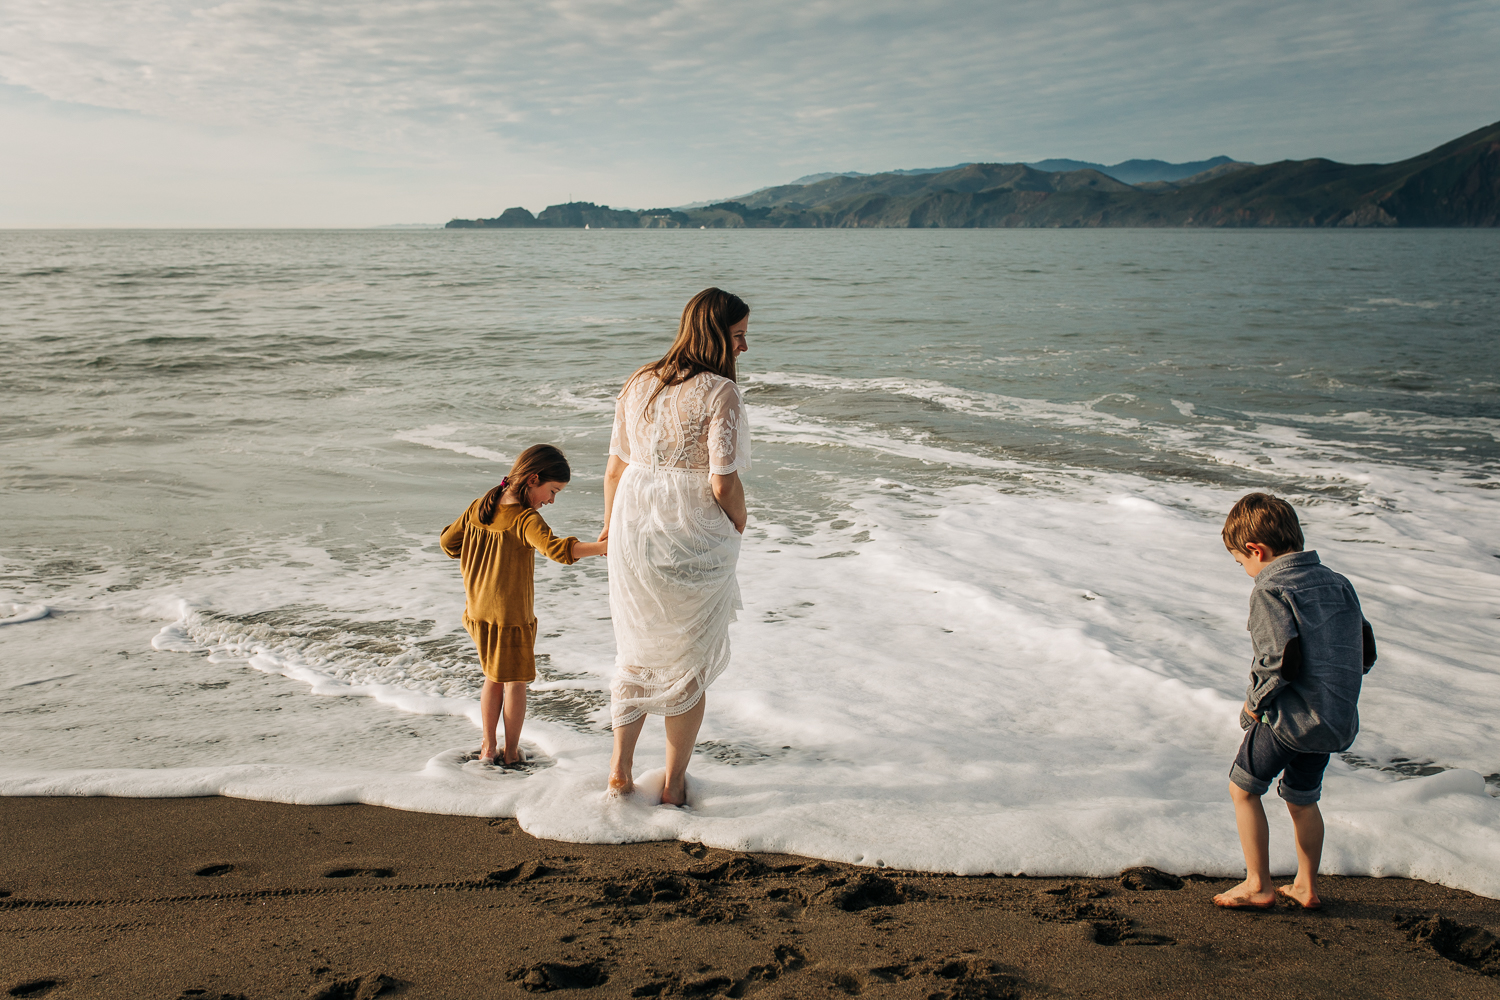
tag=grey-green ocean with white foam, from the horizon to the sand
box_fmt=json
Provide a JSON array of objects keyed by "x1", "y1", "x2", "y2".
[{"x1": 0, "y1": 229, "x2": 1500, "y2": 897}]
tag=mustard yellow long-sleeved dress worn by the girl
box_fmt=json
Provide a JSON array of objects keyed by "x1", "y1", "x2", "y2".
[{"x1": 440, "y1": 496, "x2": 578, "y2": 684}]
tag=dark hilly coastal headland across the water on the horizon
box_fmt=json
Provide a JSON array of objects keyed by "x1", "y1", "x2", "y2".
[{"x1": 447, "y1": 123, "x2": 1500, "y2": 229}]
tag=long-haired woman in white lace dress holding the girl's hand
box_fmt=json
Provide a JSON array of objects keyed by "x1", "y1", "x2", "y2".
[{"x1": 600, "y1": 288, "x2": 750, "y2": 805}]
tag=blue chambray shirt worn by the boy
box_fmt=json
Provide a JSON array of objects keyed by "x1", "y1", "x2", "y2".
[{"x1": 1241, "y1": 552, "x2": 1374, "y2": 753}]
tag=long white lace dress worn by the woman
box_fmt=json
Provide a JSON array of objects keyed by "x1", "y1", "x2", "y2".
[{"x1": 609, "y1": 372, "x2": 750, "y2": 726}]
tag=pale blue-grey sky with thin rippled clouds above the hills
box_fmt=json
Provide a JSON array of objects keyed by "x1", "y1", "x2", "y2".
[{"x1": 0, "y1": 0, "x2": 1500, "y2": 228}]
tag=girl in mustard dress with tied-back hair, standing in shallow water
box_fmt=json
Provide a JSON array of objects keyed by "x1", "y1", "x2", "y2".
[{"x1": 440, "y1": 444, "x2": 608, "y2": 765}]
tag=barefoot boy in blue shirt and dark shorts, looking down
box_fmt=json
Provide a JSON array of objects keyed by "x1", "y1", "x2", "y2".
[{"x1": 1214, "y1": 493, "x2": 1376, "y2": 910}]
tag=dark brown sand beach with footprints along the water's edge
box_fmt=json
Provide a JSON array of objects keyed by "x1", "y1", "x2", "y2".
[{"x1": 0, "y1": 798, "x2": 1500, "y2": 1000}]
